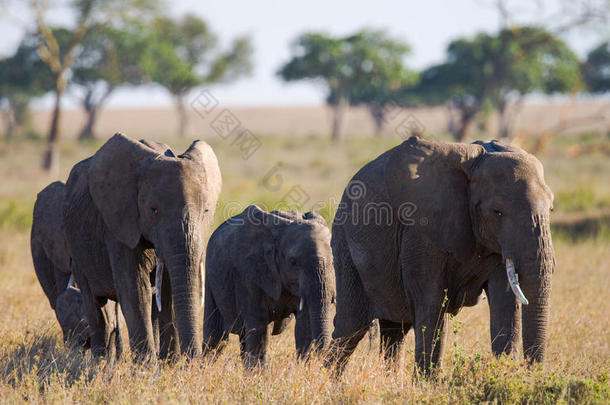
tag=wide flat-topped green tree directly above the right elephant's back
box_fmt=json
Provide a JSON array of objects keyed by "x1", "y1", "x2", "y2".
[{"x1": 415, "y1": 27, "x2": 581, "y2": 141}]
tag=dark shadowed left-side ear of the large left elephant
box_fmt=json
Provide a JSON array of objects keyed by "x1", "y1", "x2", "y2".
[{"x1": 88, "y1": 133, "x2": 160, "y2": 248}]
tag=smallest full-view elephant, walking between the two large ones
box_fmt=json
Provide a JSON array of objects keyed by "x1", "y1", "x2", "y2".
[{"x1": 203, "y1": 205, "x2": 335, "y2": 368}]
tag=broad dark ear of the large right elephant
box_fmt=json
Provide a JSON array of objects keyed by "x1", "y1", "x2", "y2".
[{"x1": 385, "y1": 137, "x2": 485, "y2": 261}]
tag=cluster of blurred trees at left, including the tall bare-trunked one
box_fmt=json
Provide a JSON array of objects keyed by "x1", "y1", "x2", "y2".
[{"x1": 0, "y1": 0, "x2": 252, "y2": 170}]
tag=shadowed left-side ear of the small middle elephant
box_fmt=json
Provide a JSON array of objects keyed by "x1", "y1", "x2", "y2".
[{"x1": 231, "y1": 205, "x2": 282, "y2": 300}]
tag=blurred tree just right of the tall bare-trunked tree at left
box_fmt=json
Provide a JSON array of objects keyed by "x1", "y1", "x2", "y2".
[{"x1": 70, "y1": 25, "x2": 147, "y2": 139}]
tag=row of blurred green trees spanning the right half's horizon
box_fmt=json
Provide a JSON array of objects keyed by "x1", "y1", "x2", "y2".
[{"x1": 278, "y1": 26, "x2": 610, "y2": 141}]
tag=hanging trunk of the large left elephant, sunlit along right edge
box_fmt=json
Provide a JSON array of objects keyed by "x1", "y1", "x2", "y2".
[{"x1": 166, "y1": 253, "x2": 201, "y2": 356}]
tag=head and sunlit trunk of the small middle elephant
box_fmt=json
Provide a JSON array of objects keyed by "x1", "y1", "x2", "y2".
[{"x1": 237, "y1": 205, "x2": 336, "y2": 355}]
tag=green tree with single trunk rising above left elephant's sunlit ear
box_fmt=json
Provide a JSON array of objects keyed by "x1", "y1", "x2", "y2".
[{"x1": 142, "y1": 14, "x2": 252, "y2": 136}]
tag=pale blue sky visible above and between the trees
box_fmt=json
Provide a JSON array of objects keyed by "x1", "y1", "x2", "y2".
[{"x1": 0, "y1": 0, "x2": 607, "y2": 107}]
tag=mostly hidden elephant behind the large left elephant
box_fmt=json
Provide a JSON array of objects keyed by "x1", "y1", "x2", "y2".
[{"x1": 30, "y1": 181, "x2": 122, "y2": 356}]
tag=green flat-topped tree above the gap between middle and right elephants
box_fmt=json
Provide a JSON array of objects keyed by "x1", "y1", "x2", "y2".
[{"x1": 278, "y1": 30, "x2": 413, "y2": 141}]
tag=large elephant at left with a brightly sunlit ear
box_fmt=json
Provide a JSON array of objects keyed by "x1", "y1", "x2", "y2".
[{"x1": 64, "y1": 134, "x2": 221, "y2": 360}]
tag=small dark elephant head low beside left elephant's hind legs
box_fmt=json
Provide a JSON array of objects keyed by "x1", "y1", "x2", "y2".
[{"x1": 55, "y1": 286, "x2": 89, "y2": 348}]
